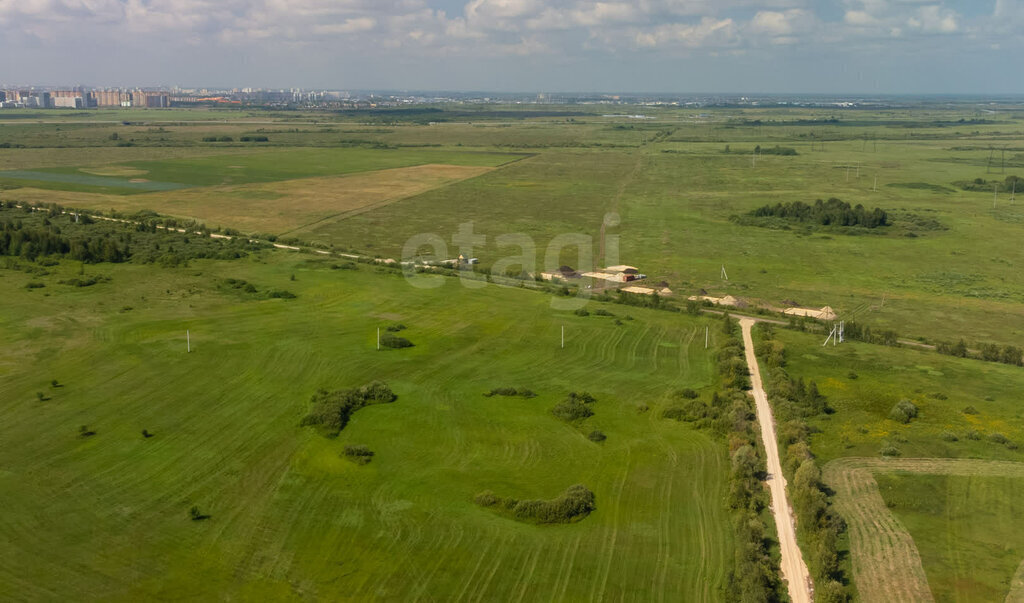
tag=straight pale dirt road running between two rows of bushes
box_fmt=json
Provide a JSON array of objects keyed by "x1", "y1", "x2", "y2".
[{"x1": 739, "y1": 318, "x2": 813, "y2": 603}]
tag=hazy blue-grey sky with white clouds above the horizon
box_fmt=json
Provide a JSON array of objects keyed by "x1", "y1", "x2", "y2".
[{"x1": 0, "y1": 0, "x2": 1024, "y2": 95}]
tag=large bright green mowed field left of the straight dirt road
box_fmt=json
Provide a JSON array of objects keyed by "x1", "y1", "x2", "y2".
[{"x1": 0, "y1": 252, "x2": 733, "y2": 601}]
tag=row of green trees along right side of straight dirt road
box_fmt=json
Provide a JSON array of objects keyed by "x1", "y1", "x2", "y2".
[{"x1": 755, "y1": 322, "x2": 849, "y2": 603}]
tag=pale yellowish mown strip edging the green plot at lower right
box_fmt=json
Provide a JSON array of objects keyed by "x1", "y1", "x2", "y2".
[{"x1": 822, "y1": 458, "x2": 1024, "y2": 602}]
